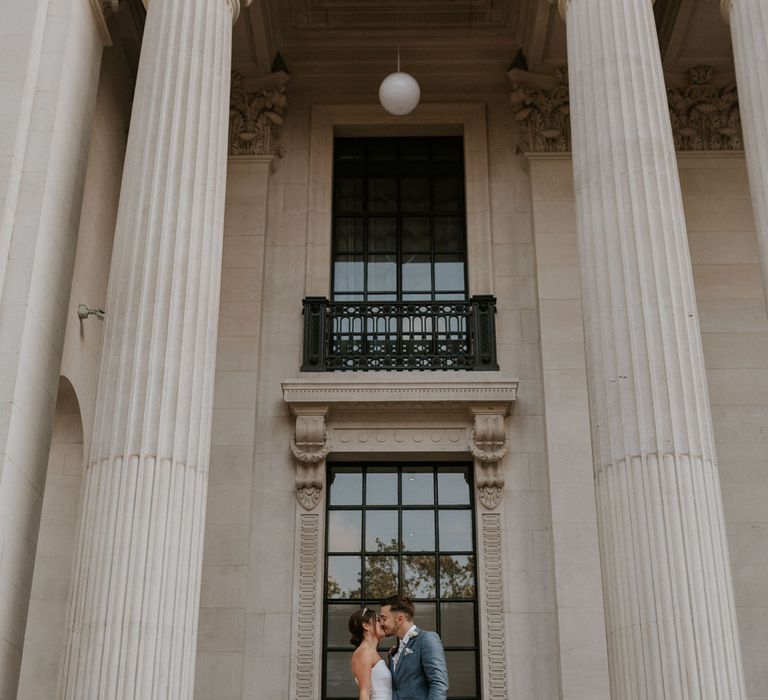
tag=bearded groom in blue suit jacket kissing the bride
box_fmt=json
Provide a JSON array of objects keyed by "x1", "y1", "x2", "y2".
[{"x1": 380, "y1": 596, "x2": 448, "y2": 700}]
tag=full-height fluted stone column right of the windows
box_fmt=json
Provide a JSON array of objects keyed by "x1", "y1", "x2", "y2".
[{"x1": 560, "y1": 0, "x2": 745, "y2": 700}]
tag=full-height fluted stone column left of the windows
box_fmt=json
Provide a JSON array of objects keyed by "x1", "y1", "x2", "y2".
[{"x1": 62, "y1": 0, "x2": 237, "y2": 700}]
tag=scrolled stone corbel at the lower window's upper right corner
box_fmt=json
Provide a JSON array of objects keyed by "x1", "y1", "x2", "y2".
[{"x1": 469, "y1": 406, "x2": 509, "y2": 510}]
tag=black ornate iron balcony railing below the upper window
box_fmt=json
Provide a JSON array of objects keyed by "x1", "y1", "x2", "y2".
[{"x1": 301, "y1": 295, "x2": 499, "y2": 372}]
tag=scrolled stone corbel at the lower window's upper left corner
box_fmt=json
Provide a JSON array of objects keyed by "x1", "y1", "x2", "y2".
[{"x1": 291, "y1": 407, "x2": 331, "y2": 510}]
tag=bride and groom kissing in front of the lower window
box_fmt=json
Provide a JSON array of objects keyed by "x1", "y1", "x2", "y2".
[{"x1": 349, "y1": 596, "x2": 448, "y2": 700}]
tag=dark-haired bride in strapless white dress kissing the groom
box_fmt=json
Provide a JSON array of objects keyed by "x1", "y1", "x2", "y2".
[{"x1": 349, "y1": 608, "x2": 392, "y2": 700}]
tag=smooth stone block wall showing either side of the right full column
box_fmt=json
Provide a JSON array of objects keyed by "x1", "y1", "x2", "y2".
[{"x1": 531, "y1": 153, "x2": 768, "y2": 700}]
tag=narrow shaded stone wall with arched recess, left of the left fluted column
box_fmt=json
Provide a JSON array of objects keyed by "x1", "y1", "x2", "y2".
[{"x1": 13, "y1": 49, "x2": 131, "y2": 700}]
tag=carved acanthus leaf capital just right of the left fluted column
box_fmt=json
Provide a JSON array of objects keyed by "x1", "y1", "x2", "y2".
[{"x1": 229, "y1": 71, "x2": 289, "y2": 157}]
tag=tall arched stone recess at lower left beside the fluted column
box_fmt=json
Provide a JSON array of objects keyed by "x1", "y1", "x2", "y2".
[{"x1": 18, "y1": 376, "x2": 84, "y2": 700}]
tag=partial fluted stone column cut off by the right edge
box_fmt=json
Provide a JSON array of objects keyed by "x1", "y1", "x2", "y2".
[{"x1": 721, "y1": 0, "x2": 768, "y2": 303}]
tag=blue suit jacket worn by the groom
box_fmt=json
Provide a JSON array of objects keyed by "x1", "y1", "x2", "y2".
[{"x1": 389, "y1": 627, "x2": 448, "y2": 700}]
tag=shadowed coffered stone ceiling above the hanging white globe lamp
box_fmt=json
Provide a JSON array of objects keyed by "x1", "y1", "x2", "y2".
[{"x1": 233, "y1": 0, "x2": 733, "y2": 92}]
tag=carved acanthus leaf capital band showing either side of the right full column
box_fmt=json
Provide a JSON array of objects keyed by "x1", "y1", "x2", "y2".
[{"x1": 507, "y1": 66, "x2": 744, "y2": 153}]
